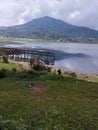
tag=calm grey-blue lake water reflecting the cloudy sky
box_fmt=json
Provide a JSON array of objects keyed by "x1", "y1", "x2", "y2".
[{"x1": 0, "y1": 42, "x2": 98, "y2": 74}]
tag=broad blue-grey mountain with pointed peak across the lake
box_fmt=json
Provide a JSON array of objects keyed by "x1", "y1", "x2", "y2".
[{"x1": 0, "y1": 16, "x2": 98, "y2": 42}]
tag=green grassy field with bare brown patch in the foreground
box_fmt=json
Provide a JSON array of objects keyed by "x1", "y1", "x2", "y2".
[{"x1": 0, "y1": 61, "x2": 98, "y2": 130}]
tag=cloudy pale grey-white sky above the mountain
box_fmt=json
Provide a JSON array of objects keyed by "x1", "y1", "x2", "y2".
[{"x1": 0, "y1": 0, "x2": 98, "y2": 30}]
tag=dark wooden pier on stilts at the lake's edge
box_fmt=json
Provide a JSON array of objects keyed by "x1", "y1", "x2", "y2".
[{"x1": 0, "y1": 47, "x2": 55, "y2": 65}]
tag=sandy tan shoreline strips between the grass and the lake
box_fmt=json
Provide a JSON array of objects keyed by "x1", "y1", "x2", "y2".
[{"x1": 11, "y1": 61, "x2": 98, "y2": 83}]
